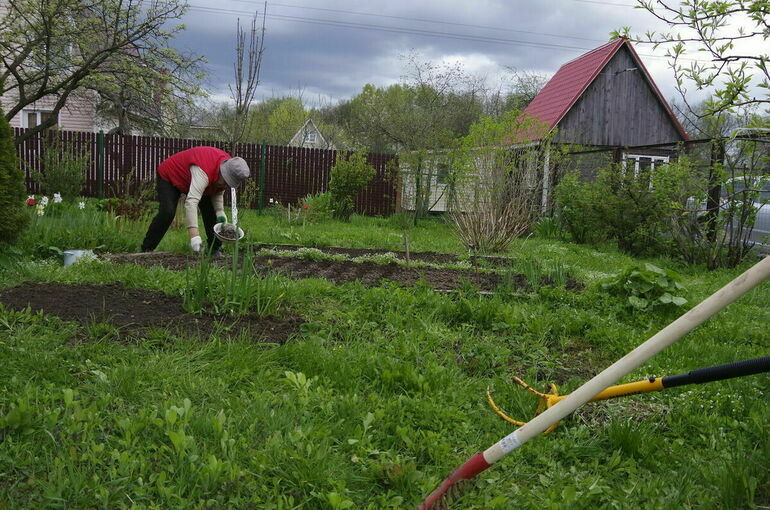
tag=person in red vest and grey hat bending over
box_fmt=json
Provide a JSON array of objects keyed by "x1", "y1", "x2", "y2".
[{"x1": 142, "y1": 147, "x2": 250, "y2": 253}]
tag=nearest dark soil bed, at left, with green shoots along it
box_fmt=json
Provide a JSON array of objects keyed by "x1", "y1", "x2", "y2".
[{"x1": 0, "y1": 283, "x2": 303, "y2": 343}]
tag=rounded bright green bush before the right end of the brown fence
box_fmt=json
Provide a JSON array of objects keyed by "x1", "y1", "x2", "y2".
[{"x1": 329, "y1": 152, "x2": 376, "y2": 221}]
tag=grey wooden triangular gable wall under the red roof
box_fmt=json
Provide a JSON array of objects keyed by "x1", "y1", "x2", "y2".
[{"x1": 556, "y1": 47, "x2": 682, "y2": 146}]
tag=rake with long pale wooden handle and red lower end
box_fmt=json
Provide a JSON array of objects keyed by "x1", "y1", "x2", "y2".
[{"x1": 419, "y1": 257, "x2": 770, "y2": 510}]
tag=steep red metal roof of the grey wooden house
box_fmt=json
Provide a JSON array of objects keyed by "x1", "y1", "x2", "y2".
[{"x1": 523, "y1": 37, "x2": 688, "y2": 140}]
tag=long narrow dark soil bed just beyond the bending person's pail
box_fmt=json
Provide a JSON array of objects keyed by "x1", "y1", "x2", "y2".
[{"x1": 107, "y1": 252, "x2": 580, "y2": 293}]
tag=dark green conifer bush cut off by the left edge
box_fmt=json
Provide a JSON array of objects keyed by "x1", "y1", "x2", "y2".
[{"x1": 0, "y1": 100, "x2": 29, "y2": 244}]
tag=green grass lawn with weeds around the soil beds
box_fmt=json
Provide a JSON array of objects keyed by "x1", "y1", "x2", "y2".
[{"x1": 0, "y1": 206, "x2": 770, "y2": 509}]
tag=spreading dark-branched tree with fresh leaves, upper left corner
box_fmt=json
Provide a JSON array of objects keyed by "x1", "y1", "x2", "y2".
[{"x1": 0, "y1": 0, "x2": 198, "y2": 141}]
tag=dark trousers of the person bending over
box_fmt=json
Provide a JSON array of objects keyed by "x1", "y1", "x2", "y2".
[{"x1": 142, "y1": 175, "x2": 222, "y2": 253}]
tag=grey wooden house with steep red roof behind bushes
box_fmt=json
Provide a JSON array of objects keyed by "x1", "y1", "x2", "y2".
[{"x1": 402, "y1": 37, "x2": 689, "y2": 211}]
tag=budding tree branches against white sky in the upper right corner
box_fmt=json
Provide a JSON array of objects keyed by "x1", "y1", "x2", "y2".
[{"x1": 614, "y1": 0, "x2": 770, "y2": 114}]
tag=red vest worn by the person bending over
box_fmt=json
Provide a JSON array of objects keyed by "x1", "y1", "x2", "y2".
[{"x1": 158, "y1": 146, "x2": 230, "y2": 195}]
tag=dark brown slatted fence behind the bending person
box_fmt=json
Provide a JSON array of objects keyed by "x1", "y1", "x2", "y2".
[{"x1": 14, "y1": 128, "x2": 397, "y2": 216}]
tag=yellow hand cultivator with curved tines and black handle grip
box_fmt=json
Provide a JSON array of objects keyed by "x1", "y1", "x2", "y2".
[{"x1": 487, "y1": 356, "x2": 770, "y2": 434}]
